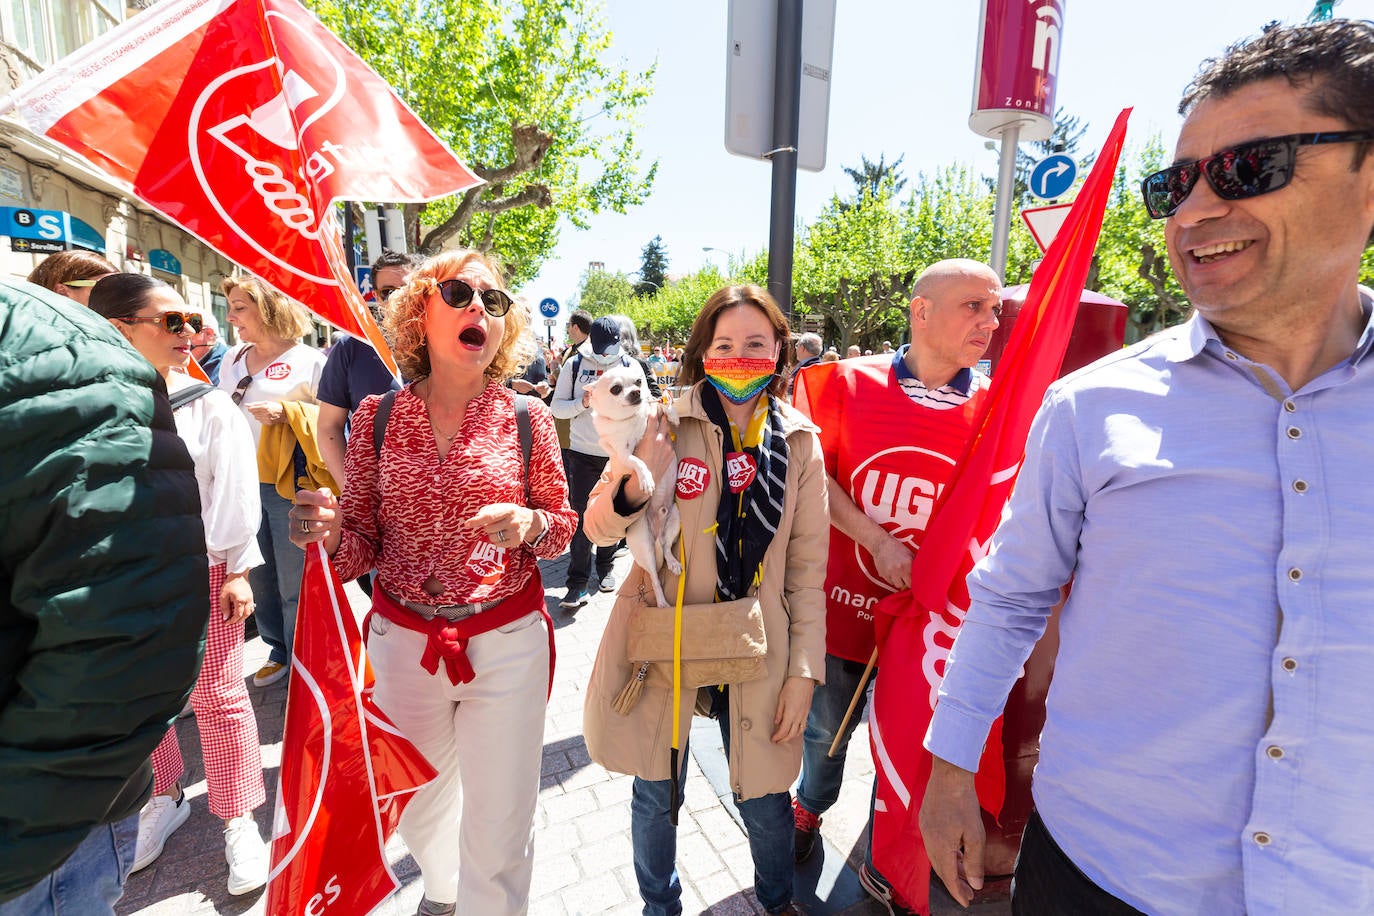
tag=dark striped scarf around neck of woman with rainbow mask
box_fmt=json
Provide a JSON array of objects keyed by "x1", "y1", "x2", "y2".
[{"x1": 701, "y1": 385, "x2": 787, "y2": 602}]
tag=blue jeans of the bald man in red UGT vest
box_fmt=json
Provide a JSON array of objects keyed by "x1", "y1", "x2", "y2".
[{"x1": 797, "y1": 652, "x2": 881, "y2": 878}]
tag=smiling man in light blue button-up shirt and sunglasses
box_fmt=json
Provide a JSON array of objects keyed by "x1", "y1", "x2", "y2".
[{"x1": 921, "y1": 21, "x2": 1374, "y2": 916}]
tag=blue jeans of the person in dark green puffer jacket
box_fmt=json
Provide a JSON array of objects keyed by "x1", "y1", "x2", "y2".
[{"x1": 0, "y1": 812, "x2": 139, "y2": 916}]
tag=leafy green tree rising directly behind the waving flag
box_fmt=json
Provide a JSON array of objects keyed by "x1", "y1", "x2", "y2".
[{"x1": 306, "y1": 0, "x2": 657, "y2": 286}]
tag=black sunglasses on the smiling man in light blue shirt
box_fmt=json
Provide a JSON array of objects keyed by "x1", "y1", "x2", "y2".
[{"x1": 1140, "y1": 130, "x2": 1374, "y2": 220}]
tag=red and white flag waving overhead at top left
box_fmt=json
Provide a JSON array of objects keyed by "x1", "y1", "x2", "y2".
[{"x1": 8, "y1": 0, "x2": 481, "y2": 371}]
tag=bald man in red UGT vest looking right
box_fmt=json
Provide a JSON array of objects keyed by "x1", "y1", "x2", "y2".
[{"x1": 794, "y1": 260, "x2": 1002, "y2": 913}]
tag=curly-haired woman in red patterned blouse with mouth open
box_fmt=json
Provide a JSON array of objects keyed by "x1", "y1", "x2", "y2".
[{"x1": 291, "y1": 251, "x2": 576, "y2": 916}]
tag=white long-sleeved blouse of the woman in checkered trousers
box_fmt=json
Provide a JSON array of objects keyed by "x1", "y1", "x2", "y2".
[{"x1": 168, "y1": 372, "x2": 262, "y2": 574}]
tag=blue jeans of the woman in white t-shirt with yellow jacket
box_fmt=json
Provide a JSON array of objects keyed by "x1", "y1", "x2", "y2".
[{"x1": 249, "y1": 483, "x2": 305, "y2": 665}]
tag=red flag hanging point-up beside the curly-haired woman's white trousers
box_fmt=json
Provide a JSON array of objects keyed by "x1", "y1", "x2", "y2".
[{"x1": 267, "y1": 545, "x2": 434, "y2": 916}]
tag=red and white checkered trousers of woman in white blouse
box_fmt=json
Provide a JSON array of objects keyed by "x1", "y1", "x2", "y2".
[{"x1": 153, "y1": 563, "x2": 267, "y2": 818}]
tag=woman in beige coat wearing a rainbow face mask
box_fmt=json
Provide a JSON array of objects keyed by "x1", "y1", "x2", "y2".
[{"x1": 584, "y1": 286, "x2": 830, "y2": 916}]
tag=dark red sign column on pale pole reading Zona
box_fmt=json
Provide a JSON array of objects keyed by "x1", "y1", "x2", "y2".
[{"x1": 969, "y1": 0, "x2": 1066, "y2": 276}]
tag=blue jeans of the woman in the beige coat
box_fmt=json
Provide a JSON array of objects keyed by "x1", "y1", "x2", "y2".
[{"x1": 629, "y1": 688, "x2": 793, "y2": 916}]
